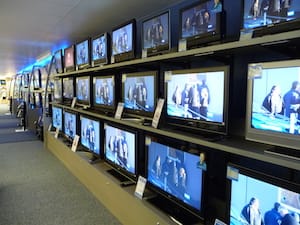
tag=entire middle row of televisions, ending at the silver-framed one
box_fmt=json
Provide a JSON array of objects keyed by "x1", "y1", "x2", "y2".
[{"x1": 54, "y1": 60, "x2": 300, "y2": 157}]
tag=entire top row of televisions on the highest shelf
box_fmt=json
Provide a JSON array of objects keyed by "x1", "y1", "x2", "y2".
[{"x1": 55, "y1": 0, "x2": 300, "y2": 73}]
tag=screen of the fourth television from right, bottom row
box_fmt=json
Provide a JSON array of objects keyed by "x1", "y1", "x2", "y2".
[{"x1": 80, "y1": 115, "x2": 101, "y2": 155}]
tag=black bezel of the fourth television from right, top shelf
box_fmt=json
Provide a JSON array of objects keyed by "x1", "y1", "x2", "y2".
[{"x1": 111, "y1": 19, "x2": 137, "y2": 63}]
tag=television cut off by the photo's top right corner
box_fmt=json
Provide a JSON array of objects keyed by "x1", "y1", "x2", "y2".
[{"x1": 243, "y1": 0, "x2": 300, "y2": 37}]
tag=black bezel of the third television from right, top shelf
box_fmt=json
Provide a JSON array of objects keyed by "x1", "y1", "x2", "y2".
[{"x1": 141, "y1": 10, "x2": 172, "y2": 56}]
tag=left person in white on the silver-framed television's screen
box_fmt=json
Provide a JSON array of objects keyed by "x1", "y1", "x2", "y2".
[{"x1": 262, "y1": 85, "x2": 283, "y2": 116}]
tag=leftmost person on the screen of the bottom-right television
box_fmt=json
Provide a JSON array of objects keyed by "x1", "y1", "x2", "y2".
[{"x1": 241, "y1": 197, "x2": 263, "y2": 225}]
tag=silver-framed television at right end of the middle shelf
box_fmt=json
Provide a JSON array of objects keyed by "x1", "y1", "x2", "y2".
[{"x1": 246, "y1": 60, "x2": 300, "y2": 156}]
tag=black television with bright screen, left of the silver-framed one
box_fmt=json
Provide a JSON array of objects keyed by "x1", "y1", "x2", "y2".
[{"x1": 165, "y1": 66, "x2": 229, "y2": 135}]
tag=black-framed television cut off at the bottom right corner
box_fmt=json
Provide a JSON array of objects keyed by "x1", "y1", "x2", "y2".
[{"x1": 228, "y1": 165, "x2": 300, "y2": 225}]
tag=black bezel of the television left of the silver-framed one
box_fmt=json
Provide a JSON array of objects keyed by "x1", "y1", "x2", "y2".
[{"x1": 164, "y1": 65, "x2": 230, "y2": 135}]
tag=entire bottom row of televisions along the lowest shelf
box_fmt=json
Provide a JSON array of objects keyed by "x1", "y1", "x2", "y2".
[{"x1": 52, "y1": 106, "x2": 300, "y2": 225}]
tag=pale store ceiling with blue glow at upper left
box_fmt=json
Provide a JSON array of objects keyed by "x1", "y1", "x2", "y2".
[{"x1": 0, "y1": 0, "x2": 183, "y2": 77}]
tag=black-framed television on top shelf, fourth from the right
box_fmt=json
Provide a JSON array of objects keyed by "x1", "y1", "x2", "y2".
[{"x1": 111, "y1": 19, "x2": 136, "y2": 62}]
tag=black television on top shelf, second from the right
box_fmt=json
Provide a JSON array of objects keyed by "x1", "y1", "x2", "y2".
[{"x1": 180, "y1": 0, "x2": 225, "y2": 49}]
